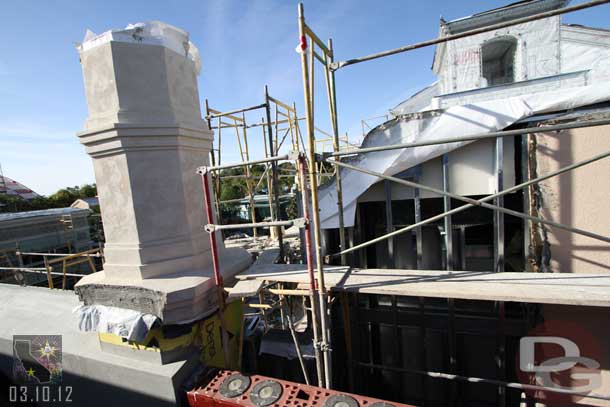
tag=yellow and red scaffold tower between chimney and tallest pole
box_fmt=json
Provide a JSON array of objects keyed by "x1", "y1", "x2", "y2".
[{"x1": 197, "y1": 86, "x2": 330, "y2": 385}]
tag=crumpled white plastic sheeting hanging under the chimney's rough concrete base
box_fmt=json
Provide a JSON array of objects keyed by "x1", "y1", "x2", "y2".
[{"x1": 74, "y1": 305, "x2": 158, "y2": 342}]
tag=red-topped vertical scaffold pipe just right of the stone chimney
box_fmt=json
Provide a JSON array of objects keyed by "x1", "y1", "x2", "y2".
[{"x1": 201, "y1": 171, "x2": 231, "y2": 368}]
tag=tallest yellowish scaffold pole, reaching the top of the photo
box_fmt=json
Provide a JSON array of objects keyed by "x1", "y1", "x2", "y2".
[{"x1": 299, "y1": 3, "x2": 332, "y2": 388}]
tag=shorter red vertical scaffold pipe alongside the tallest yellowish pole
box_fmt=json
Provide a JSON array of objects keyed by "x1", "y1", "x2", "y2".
[{"x1": 298, "y1": 154, "x2": 324, "y2": 386}]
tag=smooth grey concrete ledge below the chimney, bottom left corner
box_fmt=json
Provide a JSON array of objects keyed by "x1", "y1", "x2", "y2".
[{"x1": 0, "y1": 284, "x2": 198, "y2": 407}]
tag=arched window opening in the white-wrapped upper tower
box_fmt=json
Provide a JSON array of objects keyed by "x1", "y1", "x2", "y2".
[{"x1": 481, "y1": 37, "x2": 517, "y2": 86}]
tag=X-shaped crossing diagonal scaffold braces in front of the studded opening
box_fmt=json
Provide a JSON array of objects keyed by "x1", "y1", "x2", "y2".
[{"x1": 328, "y1": 151, "x2": 610, "y2": 257}]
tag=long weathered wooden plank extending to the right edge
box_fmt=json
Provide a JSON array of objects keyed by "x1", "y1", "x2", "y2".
[{"x1": 333, "y1": 269, "x2": 610, "y2": 307}]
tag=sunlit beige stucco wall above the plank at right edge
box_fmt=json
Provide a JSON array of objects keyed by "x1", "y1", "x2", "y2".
[{"x1": 536, "y1": 126, "x2": 610, "y2": 273}]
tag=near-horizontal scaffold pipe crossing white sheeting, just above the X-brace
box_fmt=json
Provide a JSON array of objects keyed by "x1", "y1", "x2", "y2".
[{"x1": 324, "y1": 119, "x2": 610, "y2": 157}]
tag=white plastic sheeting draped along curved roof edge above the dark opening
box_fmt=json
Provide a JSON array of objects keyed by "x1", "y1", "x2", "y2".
[{"x1": 319, "y1": 83, "x2": 610, "y2": 229}]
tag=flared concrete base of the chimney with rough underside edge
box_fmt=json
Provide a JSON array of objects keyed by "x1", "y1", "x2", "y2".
[{"x1": 74, "y1": 248, "x2": 252, "y2": 325}]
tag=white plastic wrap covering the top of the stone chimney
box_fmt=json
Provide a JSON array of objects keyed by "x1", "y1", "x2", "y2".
[{"x1": 76, "y1": 21, "x2": 201, "y2": 74}]
